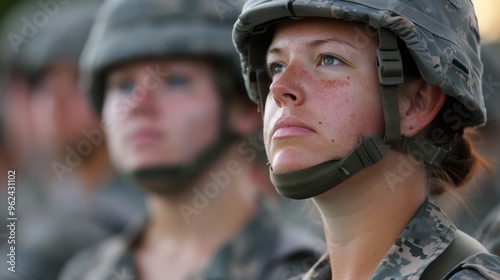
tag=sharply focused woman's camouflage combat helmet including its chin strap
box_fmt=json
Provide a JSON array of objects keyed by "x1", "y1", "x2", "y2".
[{"x1": 233, "y1": 0, "x2": 486, "y2": 199}]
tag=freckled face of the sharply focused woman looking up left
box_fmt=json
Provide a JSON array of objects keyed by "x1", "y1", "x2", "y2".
[{"x1": 264, "y1": 19, "x2": 383, "y2": 173}]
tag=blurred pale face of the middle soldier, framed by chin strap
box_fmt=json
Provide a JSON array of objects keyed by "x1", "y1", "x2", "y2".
[{"x1": 103, "y1": 58, "x2": 221, "y2": 172}]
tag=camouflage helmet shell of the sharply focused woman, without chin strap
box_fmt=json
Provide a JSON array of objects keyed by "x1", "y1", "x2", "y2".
[{"x1": 233, "y1": 0, "x2": 486, "y2": 127}]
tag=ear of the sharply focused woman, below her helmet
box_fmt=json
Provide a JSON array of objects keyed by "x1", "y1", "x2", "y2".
[{"x1": 399, "y1": 80, "x2": 446, "y2": 137}]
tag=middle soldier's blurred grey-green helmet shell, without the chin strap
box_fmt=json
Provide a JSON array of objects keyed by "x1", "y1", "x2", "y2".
[{"x1": 80, "y1": 0, "x2": 241, "y2": 113}]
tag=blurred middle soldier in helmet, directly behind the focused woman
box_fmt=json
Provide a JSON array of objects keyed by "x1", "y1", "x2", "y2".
[{"x1": 61, "y1": 0, "x2": 316, "y2": 280}]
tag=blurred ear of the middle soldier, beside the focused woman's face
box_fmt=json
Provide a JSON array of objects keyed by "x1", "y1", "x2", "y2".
[{"x1": 228, "y1": 92, "x2": 262, "y2": 136}]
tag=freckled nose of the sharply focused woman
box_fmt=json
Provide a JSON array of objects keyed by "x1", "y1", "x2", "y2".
[{"x1": 269, "y1": 64, "x2": 306, "y2": 108}]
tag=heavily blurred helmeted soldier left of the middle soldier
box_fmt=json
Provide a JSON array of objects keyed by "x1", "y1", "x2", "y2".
[{"x1": 0, "y1": 1, "x2": 145, "y2": 280}]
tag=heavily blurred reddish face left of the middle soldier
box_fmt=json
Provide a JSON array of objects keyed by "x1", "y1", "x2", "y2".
[{"x1": 30, "y1": 61, "x2": 99, "y2": 153}]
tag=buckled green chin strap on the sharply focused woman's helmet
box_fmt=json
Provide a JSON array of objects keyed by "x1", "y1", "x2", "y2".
[{"x1": 270, "y1": 28, "x2": 448, "y2": 199}]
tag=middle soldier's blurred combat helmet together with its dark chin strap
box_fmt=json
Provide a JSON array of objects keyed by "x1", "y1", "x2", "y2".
[{"x1": 80, "y1": 0, "x2": 244, "y2": 192}]
